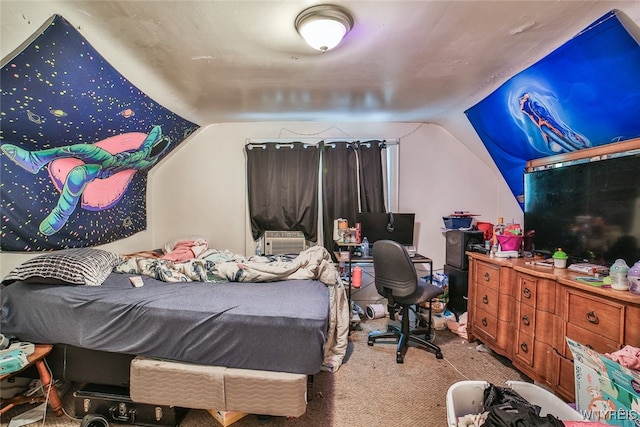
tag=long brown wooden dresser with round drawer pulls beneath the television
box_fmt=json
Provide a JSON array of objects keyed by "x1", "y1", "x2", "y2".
[{"x1": 467, "y1": 252, "x2": 640, "y2": 401}]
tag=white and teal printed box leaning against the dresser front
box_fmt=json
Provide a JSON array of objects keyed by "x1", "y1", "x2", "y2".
[{"x1": 567, "y1": 338, "x2": 640, "y2": 427}]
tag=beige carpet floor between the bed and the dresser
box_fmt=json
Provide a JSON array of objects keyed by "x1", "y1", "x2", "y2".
[{"x1": 2, "y1": 318, "x2": 527, "y2": 427}]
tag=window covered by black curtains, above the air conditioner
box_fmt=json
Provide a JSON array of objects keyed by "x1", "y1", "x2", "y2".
[{"x1": 245, "y1": 140, "x2": 397, "y2": 249}]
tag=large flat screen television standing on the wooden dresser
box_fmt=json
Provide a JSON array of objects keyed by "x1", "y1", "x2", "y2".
[{"x1": 524, "y1": 153, "x2": 640, "y2": 266}]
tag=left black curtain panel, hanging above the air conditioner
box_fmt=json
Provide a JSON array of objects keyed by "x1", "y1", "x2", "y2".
[{"x1": 245, "y1": 142, "x2": 320, "y2": 242}]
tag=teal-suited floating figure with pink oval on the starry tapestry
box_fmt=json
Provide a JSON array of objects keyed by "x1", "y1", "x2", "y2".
[{"x1": 0, "y1": 126, "x2": 171, "y2": 236}]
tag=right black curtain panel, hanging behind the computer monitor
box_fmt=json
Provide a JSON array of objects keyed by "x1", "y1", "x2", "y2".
[{"x1": 322, "y1": 141, "x2": 385, "y2": 252}]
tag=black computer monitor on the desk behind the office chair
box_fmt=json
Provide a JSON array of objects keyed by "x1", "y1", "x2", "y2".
[{"x1": 356, "y1": 212, "x2": 416, "y2": 246}]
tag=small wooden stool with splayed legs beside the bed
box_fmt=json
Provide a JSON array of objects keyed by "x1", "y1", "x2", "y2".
[{"x1": 0, "y1": 344, "x2": 63, "y2": 417}]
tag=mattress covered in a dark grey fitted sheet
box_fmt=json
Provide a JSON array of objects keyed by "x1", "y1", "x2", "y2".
[{"x1": 0, "y1": 273, "x2": 329, "y2": 375}]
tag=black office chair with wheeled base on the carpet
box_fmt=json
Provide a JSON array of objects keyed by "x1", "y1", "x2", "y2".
[{"x1": 367, "y1": 240, "x2": 444, "y2": 363}]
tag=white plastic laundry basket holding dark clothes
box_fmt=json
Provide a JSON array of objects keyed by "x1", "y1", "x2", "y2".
[{"x1": 447, "y1": 381, "x2": 584, "y2": 427}]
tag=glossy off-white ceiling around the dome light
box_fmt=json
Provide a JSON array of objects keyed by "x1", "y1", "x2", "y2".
[{"x1": 0, "y1": 0, "x2": 640, "y2": 126}]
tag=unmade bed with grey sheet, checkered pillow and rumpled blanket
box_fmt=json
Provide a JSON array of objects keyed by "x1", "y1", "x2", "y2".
[{"x1": 0, "y1": 247, "x2": 349, "y2": 416}]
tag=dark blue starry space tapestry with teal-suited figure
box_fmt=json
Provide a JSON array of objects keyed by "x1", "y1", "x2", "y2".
[{"x1": 0, "y1": 15, "x2": 198, "y2": 251}]
